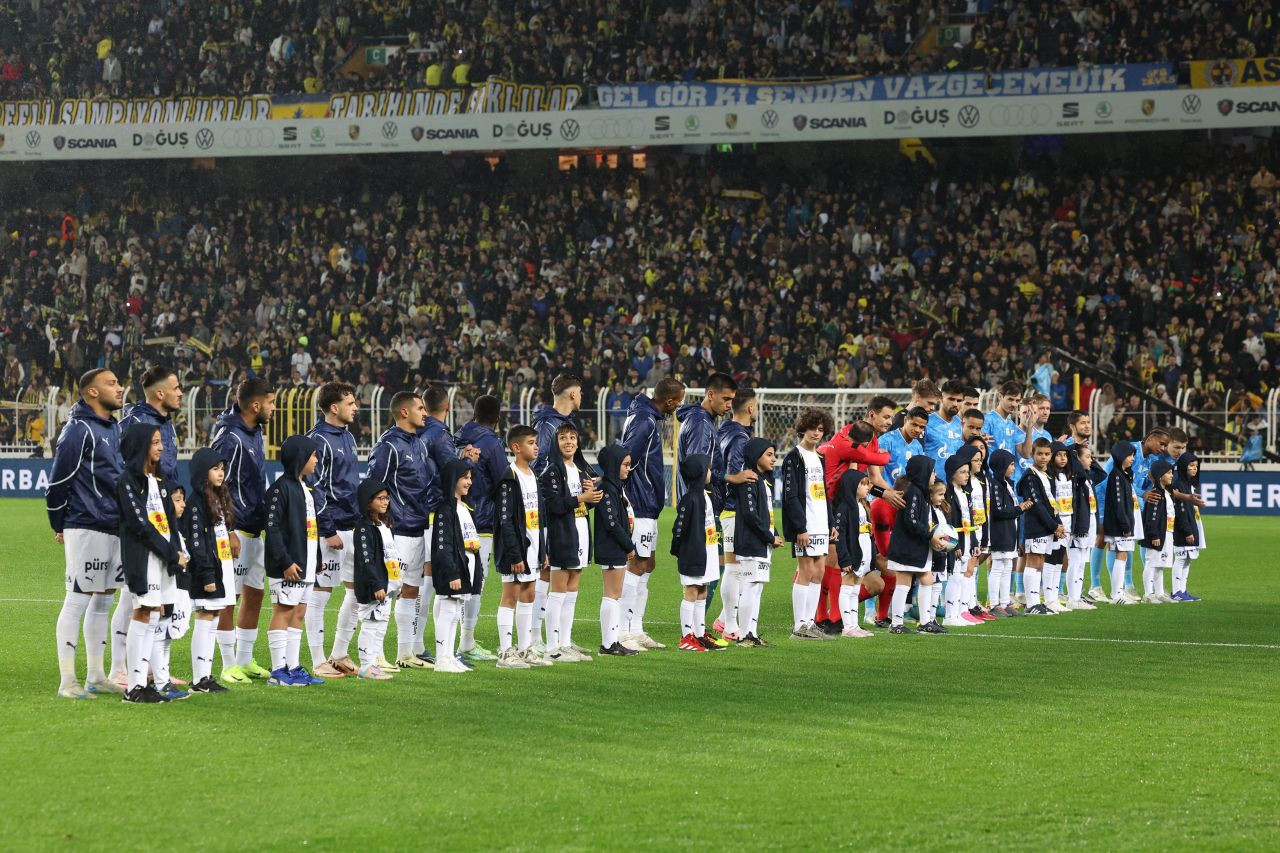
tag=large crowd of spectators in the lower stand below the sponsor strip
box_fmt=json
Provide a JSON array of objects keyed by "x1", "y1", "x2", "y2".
[{"x1": 0, "y1": 137, "x2": 1280, "y2": 450}]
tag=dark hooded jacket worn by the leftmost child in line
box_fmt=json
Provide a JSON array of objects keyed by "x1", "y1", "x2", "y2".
[{"x1": 115, "y1": 424, "x2": 184, "y2": 596}]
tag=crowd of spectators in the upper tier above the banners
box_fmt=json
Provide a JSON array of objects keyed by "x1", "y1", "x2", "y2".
[{"x1": 0, "y1": 0, "x2": 1280, "y2": 100}]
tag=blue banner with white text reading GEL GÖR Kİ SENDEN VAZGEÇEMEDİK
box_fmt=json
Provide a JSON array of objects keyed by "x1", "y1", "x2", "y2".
[{"x1": 595, "y1": 64, "x2": 1178, "y2": 109}]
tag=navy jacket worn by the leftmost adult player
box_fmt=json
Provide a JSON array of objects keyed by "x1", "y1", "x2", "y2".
[{"x1": 45, "y1": 400, "x2": 124, "y2": 535}]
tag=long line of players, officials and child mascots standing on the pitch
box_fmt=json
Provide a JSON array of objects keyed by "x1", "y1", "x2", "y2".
[{"x1": 47, "y1": 368, "x2": 1203, "y2": 701}]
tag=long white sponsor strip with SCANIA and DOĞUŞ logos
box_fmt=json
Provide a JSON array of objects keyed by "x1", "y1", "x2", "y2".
[{"x1": 0, "y1": 86, "x2": 1280, "y2": 163}]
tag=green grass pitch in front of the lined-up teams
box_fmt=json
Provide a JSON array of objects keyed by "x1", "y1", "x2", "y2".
[{"x1": 0, "y1": 500, "x2": 1280, "y2": 850}]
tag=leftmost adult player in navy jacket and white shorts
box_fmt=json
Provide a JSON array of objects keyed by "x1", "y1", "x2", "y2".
[{"x1": 45, "y1": 369, "x2": 124, "y2": 699}]
